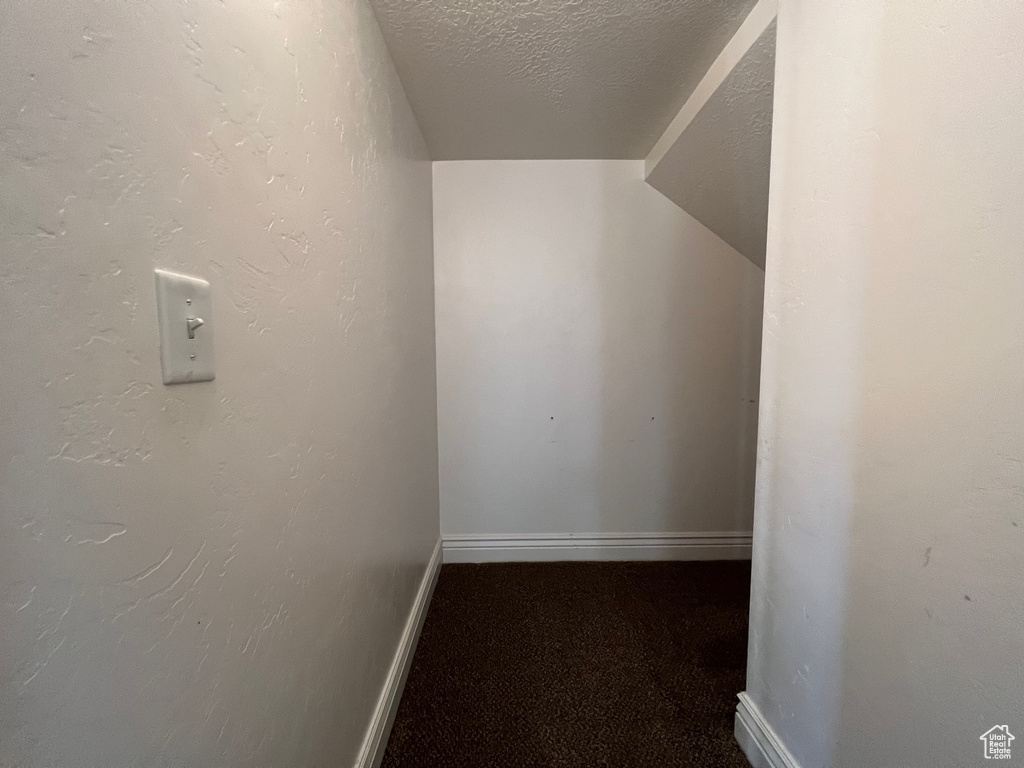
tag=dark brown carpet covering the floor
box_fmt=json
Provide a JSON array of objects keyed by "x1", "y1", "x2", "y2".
[{"x1": 382, "y1": 562, "x2": 751, "y2": 768}]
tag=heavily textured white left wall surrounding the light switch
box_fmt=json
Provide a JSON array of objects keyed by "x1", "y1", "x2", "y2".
[{"x1": 0, "y1": 0, "x2": 438, "y2": 768}]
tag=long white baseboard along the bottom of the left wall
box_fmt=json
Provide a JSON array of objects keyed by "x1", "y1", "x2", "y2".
[{"x1": 355, "y1": 541, "x2": 441, "y2": 768}]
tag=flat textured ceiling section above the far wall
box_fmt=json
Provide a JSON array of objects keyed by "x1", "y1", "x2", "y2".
[{"x1": 371, "y1": 0, "x2": 754, "y2": 160}]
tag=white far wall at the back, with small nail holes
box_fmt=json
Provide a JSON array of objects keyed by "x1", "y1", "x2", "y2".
[{"x1": 434, "y1": 161, "x2": 763, "y2": 535}]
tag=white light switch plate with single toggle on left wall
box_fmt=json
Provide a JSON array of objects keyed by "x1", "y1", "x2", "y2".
[{"x1": 156, "y1": 269, "x2": 214, "y2": 384}]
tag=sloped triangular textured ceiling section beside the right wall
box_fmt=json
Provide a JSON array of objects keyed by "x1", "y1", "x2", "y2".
[{"x1": 647, "y1": 22, "x2": 775, "y2": 269}]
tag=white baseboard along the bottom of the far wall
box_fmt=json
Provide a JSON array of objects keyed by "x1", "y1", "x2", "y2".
[{"x1": 442, "y1": 531, "x2": 753, "y2": 562}]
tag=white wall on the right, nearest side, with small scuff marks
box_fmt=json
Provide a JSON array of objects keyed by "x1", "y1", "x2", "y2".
[{"x1": 748, "y1": 0, "x2": 1024, "y2": 768}]
